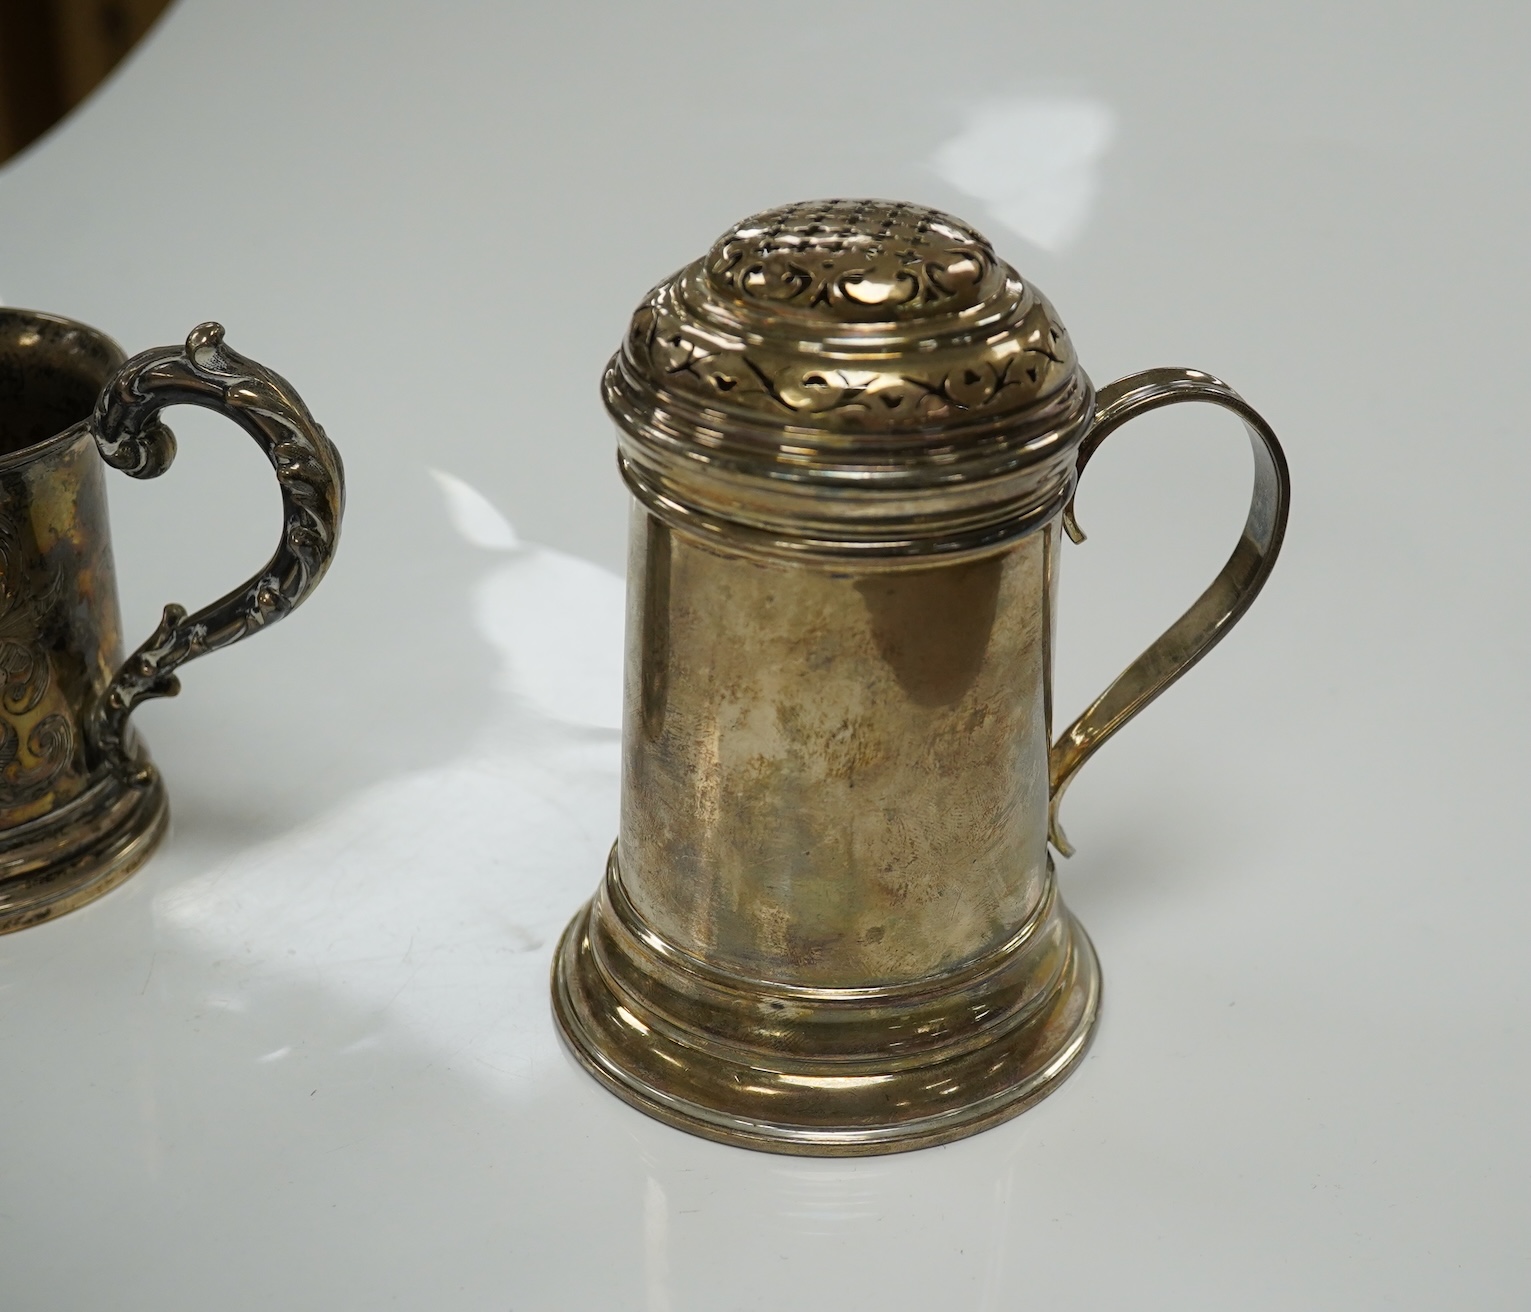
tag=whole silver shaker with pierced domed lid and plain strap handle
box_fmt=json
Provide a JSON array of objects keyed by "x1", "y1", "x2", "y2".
[{"x1": 553, "y1": 201, "x2": 1288, "y2": 1154}]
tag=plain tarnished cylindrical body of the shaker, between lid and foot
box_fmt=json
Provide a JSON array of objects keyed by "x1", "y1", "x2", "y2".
[{"x1": 617, "y1": 508, "x2": 1056, "y2": 987}]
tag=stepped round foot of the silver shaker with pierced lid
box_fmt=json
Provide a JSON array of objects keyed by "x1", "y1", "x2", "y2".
[{"x1": 553, "y1": 865, "x2": 1101, "y2": 1156}]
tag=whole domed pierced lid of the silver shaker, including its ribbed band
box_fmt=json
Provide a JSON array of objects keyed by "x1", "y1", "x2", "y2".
[{"x1": 605, "y1": 201, "x2": 1095, "y2": 563}]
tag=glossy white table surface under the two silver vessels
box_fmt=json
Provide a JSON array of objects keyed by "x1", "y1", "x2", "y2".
[{"x1": 0, "y1": 0, "x2": 1531, "y2": 1312}]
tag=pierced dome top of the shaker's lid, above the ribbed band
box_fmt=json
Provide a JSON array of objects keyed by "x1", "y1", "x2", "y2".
[{"x1": 614, "y1": 201, "x2": 1078, "y2": 436}]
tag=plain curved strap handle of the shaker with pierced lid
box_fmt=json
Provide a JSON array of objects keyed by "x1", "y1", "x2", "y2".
[{"x1": 1047, "y1": 369, "x2": 1292, "y2": 856}]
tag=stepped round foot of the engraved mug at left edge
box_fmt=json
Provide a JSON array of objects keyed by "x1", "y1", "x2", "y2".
[{"x1": 0, "y1": 762, "x2": 170, "y2": 934}]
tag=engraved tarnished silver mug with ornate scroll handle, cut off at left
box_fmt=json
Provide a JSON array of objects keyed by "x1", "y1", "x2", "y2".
[{"x1": 0, "y1": 309, "x2": 344, "y2": 934}]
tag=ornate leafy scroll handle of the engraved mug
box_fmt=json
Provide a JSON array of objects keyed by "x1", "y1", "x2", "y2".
[{"x1": 86, "y1": 323, "x2": 346, "y2": 787}]
